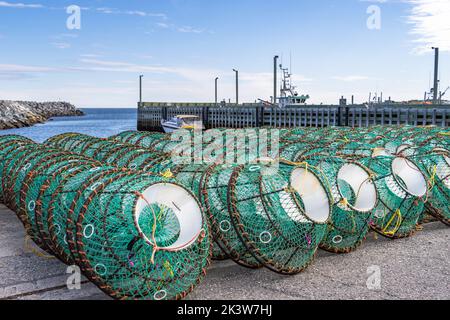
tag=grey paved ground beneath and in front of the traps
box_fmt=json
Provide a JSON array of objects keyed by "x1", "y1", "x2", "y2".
[{"x1": 0, "y1": 205, "x2": 450, "y2": 300}]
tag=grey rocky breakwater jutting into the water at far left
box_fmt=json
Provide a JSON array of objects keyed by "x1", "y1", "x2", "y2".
[{"x1": 0, "y1": 100, "x2": 84, "y2": 130}]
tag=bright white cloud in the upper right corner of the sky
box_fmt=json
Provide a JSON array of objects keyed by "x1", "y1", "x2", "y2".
[{"x1": 407, "y1": 0, "x2": 450, "y2": 54}]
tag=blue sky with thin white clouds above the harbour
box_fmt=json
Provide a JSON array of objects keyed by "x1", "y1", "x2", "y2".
[{"x1": 0, "y1": 0, "x2": 450, "y2": 107}]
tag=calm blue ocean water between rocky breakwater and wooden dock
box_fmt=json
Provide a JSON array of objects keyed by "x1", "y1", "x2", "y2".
[{"x1": 0, "y1": 108, "x2": 137, "y2": 142}]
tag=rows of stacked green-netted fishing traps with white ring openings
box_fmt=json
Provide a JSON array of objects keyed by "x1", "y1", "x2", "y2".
[{"x1": 0, "y1": 127, "x2": 450, "y2": 300}]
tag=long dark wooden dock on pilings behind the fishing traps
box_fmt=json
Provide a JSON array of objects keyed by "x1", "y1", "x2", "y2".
[{"x1": 138, "y1": 102, "x2": 450, "y2": 131}]
